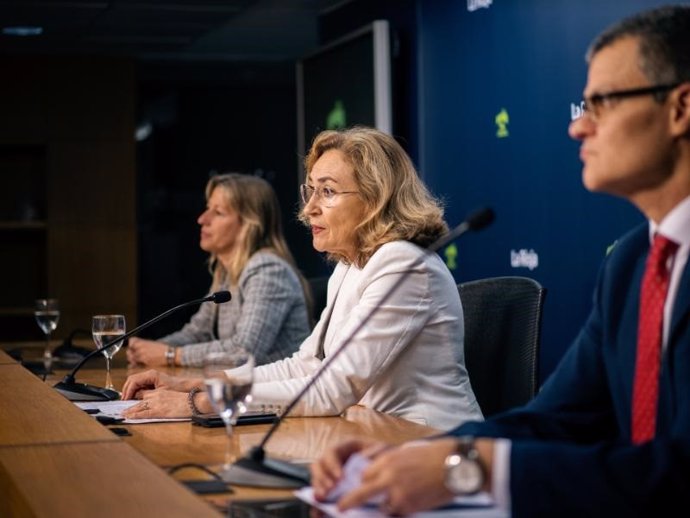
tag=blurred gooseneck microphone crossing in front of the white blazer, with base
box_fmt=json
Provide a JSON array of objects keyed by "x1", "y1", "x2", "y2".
[{"x1": 222, "y1": 207, "x2": 496, "y2": 488}]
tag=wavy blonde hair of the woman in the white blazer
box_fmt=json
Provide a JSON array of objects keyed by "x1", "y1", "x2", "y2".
[{"x1": 299, "y1": 126, "x2": 448, "y2": 268}]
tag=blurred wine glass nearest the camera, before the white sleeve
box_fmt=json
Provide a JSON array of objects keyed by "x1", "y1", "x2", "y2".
[{"x1": 204, "y1": 350, "x2": 254, "y2": 467}]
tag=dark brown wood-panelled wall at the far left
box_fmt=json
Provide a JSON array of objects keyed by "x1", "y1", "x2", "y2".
[{"x1": 0, "y1": 55, "x2": 137, "y2": 341}]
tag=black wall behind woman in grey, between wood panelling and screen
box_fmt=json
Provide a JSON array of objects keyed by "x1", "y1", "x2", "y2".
[{"x1": 138, "y1": 65, "x2": 314, "y2": 336}]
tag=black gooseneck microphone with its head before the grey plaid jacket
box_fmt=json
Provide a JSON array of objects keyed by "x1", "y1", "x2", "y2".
[{"x1": 53, "y1": 291, "x2": 231, "y2": 401}]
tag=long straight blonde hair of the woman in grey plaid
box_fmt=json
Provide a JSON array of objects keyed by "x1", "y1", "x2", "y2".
[{"x1": 205, "y1": 173, "x2": 311, "y2": 305}]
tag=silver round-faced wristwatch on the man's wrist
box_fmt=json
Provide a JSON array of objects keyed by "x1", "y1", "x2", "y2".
[{"x1": 445, "y1": 437, "x2": 486, "y2": 495}]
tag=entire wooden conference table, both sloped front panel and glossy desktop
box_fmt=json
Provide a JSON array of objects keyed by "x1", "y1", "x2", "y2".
[{"x1": 0, "y1": 355, "x2": 437, "y2": 518}]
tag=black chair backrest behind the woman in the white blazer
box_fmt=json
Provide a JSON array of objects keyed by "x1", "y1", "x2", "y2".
[{"x1": 458, "y1": 276, "x2": 546, "y2": 417}]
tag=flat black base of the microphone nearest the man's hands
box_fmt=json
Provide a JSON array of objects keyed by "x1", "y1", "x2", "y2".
[{"x1": 221, "y1": 457, "x2": 310, "y2": 489}]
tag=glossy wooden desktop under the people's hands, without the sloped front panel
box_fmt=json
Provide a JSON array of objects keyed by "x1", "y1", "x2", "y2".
[{"x1": 78, "y1": 367, "x2": 438, "y2": 505}]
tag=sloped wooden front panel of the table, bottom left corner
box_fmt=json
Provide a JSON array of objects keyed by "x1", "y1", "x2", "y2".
[{"x1": 0, "y1": 363, "x2": 218, "y2": 518}]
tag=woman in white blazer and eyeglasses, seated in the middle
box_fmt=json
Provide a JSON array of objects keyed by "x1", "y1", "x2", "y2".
[{"x1": 123, "y1": 127, "x2": 481, "y2": 429}]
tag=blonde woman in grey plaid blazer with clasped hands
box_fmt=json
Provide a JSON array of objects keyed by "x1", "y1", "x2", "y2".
[{"x1": 127, "y1": 173, "x2": 310, "y2": 366}]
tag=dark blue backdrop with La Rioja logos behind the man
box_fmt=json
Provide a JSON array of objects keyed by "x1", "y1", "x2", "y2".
[{"x1": 418, "y1": 0, "x2": 664, "y2": 380}]
